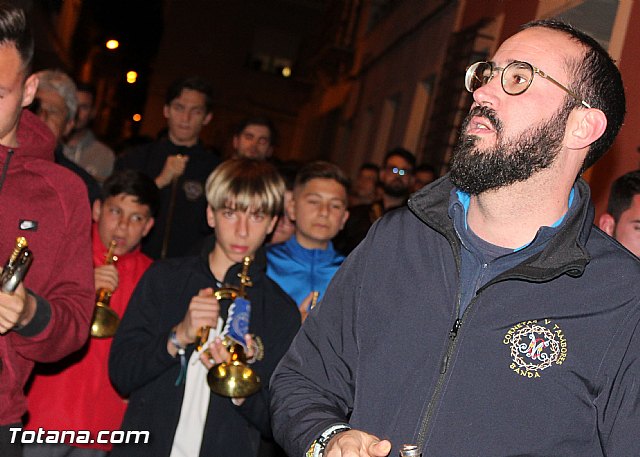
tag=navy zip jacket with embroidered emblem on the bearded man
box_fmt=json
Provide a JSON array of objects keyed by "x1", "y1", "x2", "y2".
[{"x1": 271, "y1": 178, "x2": 640, "y2": 457}]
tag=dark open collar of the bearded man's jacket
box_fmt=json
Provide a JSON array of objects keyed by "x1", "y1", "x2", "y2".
[{"x1": 408, "y1": 175, "x2": 594, "y2": 283}]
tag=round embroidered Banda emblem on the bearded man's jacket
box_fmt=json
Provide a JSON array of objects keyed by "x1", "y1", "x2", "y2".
[{"x1": 502, "y1": 319, "x2": 567, "y2": 378}]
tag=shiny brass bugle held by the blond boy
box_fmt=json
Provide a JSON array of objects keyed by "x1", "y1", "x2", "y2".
[{"x1": 204, "y1": 257, "x2": 261, "y2": 398}]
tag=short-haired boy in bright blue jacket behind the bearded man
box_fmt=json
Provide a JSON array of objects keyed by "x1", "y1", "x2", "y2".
[{"x1": 267, "y1": 161, "x2": 349, "y2": 320}]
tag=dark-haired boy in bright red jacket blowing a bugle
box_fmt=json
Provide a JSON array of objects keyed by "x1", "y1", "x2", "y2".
[{"x1": 24, "y1": 170, "x2": 159, "y2": 457}]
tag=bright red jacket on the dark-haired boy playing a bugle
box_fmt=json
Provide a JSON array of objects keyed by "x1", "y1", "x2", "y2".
[{"x1": 25, "y1": 225, "x2": 151, "y2": 450}]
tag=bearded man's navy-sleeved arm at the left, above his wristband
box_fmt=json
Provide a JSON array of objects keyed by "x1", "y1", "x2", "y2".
[{"x1": 271, "y1": 232, "x2": 380, "y2": 456}]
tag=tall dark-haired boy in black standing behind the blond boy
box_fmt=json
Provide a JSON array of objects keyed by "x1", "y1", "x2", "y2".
[{"x1": 115, "y1": 77, "x2": 220, "y2": 259}]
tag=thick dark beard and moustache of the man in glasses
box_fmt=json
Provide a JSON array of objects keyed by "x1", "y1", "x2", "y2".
[{"x1": 450, "y1": 103, "x2": 573, "y2": 195}]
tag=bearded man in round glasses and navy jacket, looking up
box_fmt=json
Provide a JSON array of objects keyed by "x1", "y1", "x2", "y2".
[{"x1": 271, "y1": 21, "x2": 640, "y2": 457}]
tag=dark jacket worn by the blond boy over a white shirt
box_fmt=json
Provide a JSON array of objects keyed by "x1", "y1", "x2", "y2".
[{"x1": 109, "y1": 248, "x2": 300, "y2": 457}]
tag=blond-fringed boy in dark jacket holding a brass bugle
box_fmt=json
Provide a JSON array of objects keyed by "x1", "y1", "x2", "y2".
[{"x1": 109, "y1": 159, "x2": 300, "y2": 457}]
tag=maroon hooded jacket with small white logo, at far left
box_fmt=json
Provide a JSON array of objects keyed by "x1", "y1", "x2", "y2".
[{"x1": 0, "y1": 111, "x2": 94, "y2": 425}]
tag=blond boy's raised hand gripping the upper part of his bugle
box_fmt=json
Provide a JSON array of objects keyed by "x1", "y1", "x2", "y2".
[{"x1": 176, "y1": 287, "x2": 220, "y2": 346}]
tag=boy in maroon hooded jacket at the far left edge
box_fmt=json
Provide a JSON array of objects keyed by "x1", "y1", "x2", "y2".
[{"x1": 0, "y1": 2, "x2": 94, "y2": 457}]
